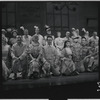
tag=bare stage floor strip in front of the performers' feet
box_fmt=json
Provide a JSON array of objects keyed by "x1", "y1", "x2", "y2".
[{"x1": 3, "y1": 72, "x2": 99, "y2": 90}]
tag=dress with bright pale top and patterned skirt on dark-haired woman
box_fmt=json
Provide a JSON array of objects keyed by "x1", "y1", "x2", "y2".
[{"x1": 61, "y1": 47, "x2": 76, "y2": 75}]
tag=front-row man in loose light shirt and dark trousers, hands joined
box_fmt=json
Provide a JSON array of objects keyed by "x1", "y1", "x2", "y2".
[{"x1": 11, "y1": 35, "x2": 27, "y2": 79}]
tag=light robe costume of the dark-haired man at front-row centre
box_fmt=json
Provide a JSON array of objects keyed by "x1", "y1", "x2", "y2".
[{"x1": 43, "y1": 45, "x2": 60, "y2": 75}]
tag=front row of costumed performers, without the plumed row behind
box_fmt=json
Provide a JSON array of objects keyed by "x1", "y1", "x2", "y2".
[{"x1": 2, "y1": 31, "x2": 99, "y2": 80}]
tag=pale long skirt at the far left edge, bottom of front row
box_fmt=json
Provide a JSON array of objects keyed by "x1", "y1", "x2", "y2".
[{"x1": 2, "y1": 60, "x2": 10, "y2": 80}]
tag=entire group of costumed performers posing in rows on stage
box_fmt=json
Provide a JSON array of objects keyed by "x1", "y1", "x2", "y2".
[{"x1": 2, "y1": 25, "x2": 99, "y2": 80}]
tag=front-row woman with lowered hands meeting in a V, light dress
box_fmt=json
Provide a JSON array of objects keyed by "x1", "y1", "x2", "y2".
[{"x1": 28, "y1": 35, "x2": 49, "y2": 78}]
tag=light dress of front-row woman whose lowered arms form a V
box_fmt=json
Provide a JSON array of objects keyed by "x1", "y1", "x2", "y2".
[{"x1": 28, "y1": 42, "x2": 42, "y2": 76}]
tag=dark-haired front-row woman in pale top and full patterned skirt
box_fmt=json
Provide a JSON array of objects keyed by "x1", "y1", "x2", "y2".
[{"x1": 61, "y1": 40, "x2": 79, "y2": 75}]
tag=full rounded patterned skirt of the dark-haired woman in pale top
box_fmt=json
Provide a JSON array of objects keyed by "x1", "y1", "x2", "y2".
[{"x1": 61, "y1": 58, "x2": 76, "y2": 75}]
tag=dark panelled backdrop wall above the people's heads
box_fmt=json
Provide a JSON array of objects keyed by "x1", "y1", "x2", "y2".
[{"x1": 2, "y1": 1, "x2": 100, "y2": 36}]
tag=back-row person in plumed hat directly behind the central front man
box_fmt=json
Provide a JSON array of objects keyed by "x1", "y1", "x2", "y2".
[{"x1": 44, "y1": 25, "x2": 55, "y2": 46}]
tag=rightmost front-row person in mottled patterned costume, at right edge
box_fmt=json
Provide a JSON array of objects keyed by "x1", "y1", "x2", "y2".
[{"x1": 84, "y1": 41, "x2": 99, "y2": 72}]
